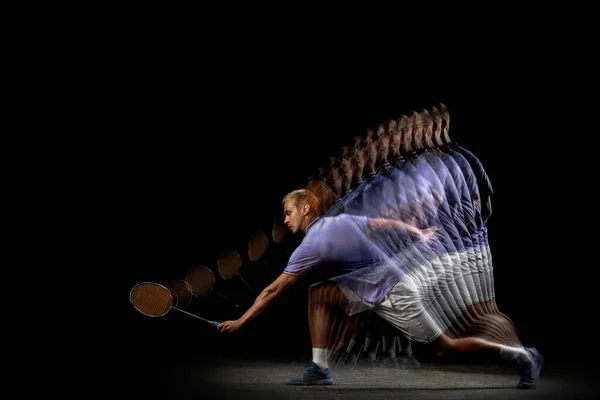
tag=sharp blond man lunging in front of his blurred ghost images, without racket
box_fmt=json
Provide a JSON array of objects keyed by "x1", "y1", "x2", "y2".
[{"x1": 218, "y1": 184, "x2": 542, "y2": 389}]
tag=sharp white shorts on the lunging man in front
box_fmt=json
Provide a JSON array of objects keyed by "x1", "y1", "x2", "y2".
[{"x1": 373, "y1": 276, "x2": 443, "y2": 343}]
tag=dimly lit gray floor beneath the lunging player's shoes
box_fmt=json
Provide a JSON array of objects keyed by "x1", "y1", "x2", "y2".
[{"x1": 137, "y1": 360, "x2": 600, "y2": 400}]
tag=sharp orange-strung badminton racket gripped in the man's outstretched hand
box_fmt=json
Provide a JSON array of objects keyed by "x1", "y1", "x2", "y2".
[{"x1": 129, "y1": 282, "x2": 219, "y2": 328}]
